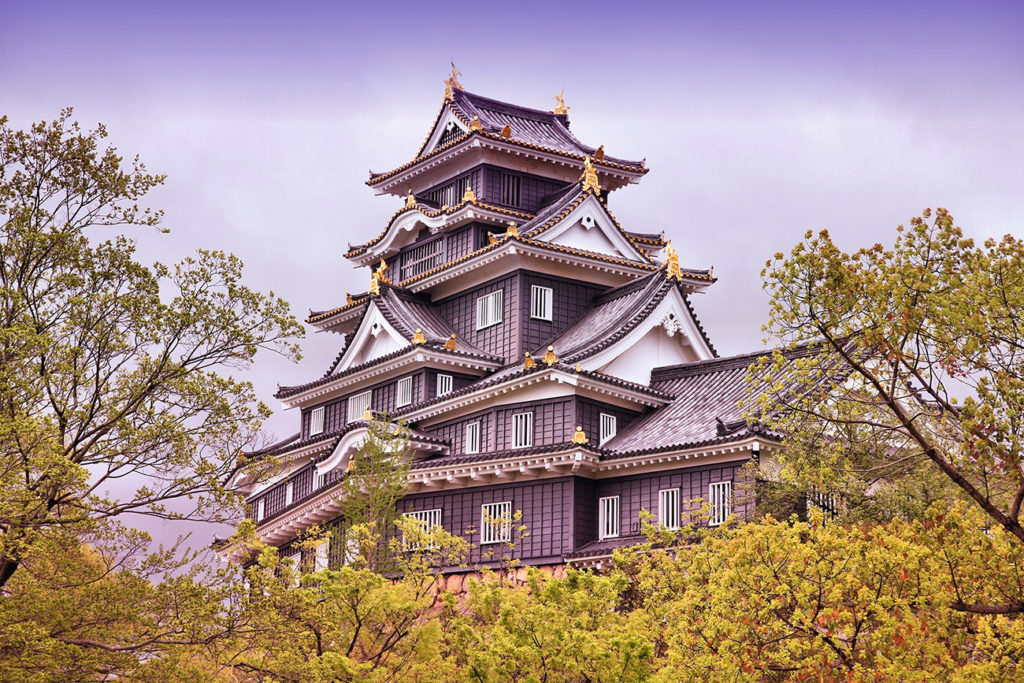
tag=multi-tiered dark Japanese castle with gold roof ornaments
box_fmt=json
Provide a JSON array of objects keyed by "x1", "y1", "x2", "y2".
[{"x1": 222, "y1": 69, "x2": 779, "y2": 570}]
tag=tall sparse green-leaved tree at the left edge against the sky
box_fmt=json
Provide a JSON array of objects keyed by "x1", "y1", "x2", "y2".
[{"x1": 0, "y1": 110, "x2": 302, "y2": 589}]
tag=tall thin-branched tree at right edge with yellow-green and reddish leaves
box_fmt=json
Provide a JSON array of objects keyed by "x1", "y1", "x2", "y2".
[{"x1": 753, "y1": 209, "x2": 1024, "y2": 613}]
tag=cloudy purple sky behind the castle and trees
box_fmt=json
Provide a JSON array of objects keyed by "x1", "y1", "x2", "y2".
[{"x1": 0, "y1": 0, "x2": 1024, "y2": 544}]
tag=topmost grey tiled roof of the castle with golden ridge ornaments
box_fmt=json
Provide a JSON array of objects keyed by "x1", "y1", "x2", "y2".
[{"x1": 367, "y1": 88, "x2": 647, "y2": 196}]
